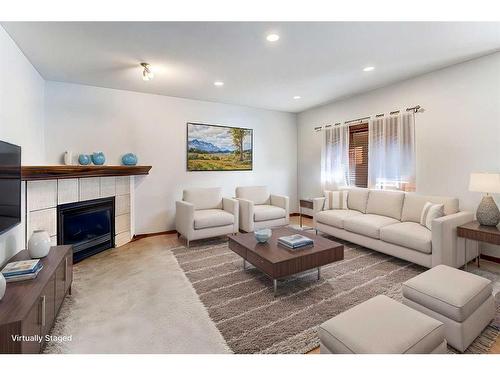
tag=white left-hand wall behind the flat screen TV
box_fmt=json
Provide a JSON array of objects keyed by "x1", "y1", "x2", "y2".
[{"x1": 0, "y1": 26, "x2": 44, "y2": 265}]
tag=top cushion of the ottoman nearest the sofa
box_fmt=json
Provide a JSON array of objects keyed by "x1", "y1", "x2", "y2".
[{"x1": 403, "y1": 264, "x2": 492, "y2": 322}]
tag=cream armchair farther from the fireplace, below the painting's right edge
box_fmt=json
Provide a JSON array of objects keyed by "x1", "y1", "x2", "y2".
[{"x1": 236, "y1": 186, "x2": 290, "y2": 232}]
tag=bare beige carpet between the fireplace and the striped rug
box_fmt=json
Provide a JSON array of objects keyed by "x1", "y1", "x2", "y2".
[{"x1": 45, "y1": 236, "x2": 230, "y2": 354}]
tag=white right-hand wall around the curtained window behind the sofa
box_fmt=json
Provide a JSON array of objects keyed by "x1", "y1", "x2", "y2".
[{"x1": 297, "y1": 53, "x2": 500, "y2": 256}]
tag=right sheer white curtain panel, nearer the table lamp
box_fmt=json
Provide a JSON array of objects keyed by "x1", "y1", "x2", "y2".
[{"x1": 368, "y1": 111, "x2": 415, "y2": 191}]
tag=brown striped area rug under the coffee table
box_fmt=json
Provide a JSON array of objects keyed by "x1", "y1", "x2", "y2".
[{"x1": 172, "y1": 242, "x2": 500, "y2": 353}]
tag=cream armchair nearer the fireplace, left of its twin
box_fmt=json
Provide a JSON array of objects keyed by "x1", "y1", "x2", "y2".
[{"x1": 175, "y1": 188, "x2": 239, "y2": 247}]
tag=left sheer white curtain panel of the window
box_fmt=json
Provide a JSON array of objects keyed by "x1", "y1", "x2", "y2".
[{"x1": 321, "y1": 124, "x2": 349, "y2": 190}]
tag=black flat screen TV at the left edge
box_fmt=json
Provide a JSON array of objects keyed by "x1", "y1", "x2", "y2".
[{"x1": 0, "y1": 141, "x2": 21, "y2": 234}]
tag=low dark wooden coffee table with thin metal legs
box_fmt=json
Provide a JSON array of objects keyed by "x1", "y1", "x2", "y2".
[{"x1": 228, "y1": 227, "x2": 344, "y2": 296}]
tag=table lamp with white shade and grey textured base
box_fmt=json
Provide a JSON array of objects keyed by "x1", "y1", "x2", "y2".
[{"x1": 469, "y1": 173, "x2": 500, "y2": 226}]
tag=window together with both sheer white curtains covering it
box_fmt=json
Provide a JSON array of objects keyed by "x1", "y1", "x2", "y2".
[{"x1": 321, "y1": 111, "x2": 416, "y2": 191}]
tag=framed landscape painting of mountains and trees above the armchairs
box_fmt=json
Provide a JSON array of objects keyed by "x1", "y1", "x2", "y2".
[{"x1": 187, "y1": 122, "x2": 253, "y2": 171}]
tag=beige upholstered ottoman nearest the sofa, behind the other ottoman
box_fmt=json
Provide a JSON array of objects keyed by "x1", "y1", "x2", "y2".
[{"x1": 403, "y1": 265, "x2": 495, "y2": 352}]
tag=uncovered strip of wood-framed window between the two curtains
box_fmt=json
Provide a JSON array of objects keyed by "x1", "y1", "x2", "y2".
[{"x1": 349, "y1": 123, "x2": 368, "y2": 187}]
